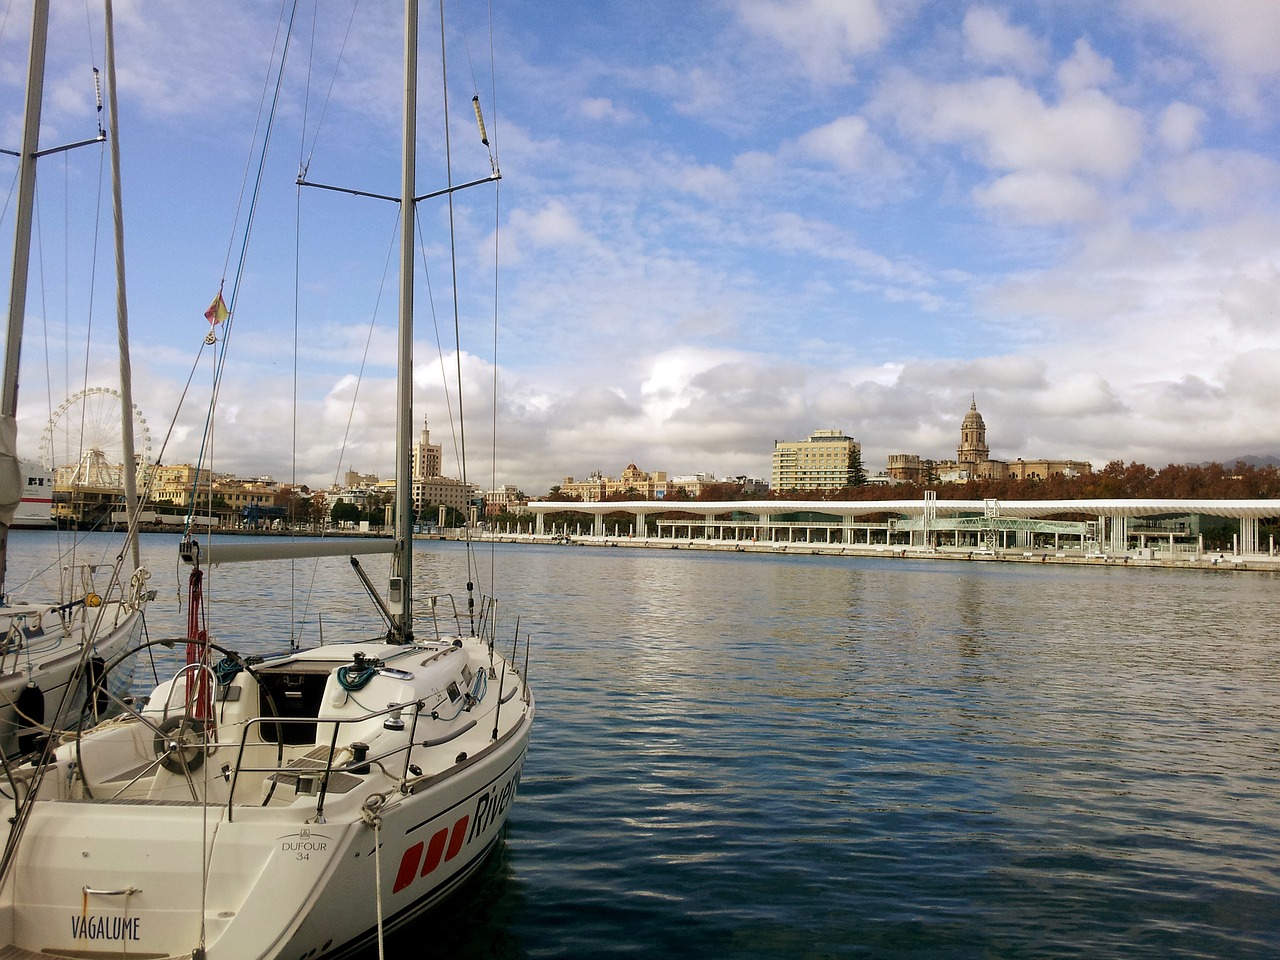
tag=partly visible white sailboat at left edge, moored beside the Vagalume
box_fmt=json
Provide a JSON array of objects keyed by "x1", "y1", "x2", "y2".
[{"x1": 0, "y1": 0, "x2": 151, "y2": 756}]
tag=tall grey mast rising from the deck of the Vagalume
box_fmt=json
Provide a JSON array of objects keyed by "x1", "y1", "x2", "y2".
[{"x1": 390, "y1": 0, "x2": 417, "y2": 643}]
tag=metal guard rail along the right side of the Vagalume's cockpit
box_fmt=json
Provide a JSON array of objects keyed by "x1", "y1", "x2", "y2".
[{"x1": 227, "y1": 700, "x2": 460, "y2": 823}]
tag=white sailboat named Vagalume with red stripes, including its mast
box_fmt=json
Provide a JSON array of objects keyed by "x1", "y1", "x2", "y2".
[{"x1": 0, "y1": 0, "x2": 534, "y2": 960}]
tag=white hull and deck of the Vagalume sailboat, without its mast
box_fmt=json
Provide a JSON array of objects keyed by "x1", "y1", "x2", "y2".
[{"x1": 0, "y1": 639, "x2": 534, "y2": 960}]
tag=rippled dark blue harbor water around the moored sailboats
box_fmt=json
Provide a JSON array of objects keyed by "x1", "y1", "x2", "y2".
[{"x1": 9, "y1": 531, "x2": 1280, "y2": 960}]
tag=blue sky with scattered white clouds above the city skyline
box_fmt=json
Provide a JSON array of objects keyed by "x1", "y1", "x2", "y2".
[{"x1": 0, "y1": 0, "x2": 1280, "y2": 494}]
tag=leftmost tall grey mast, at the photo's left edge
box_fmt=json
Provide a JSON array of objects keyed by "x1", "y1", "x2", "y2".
[{"x1": 0, "y1": 0, "x2": 49, "y2": 598}]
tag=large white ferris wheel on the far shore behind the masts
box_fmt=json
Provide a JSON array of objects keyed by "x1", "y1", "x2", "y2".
[{"x1": 40, "y1": 387, "x2": 151, "y2": 489}]
